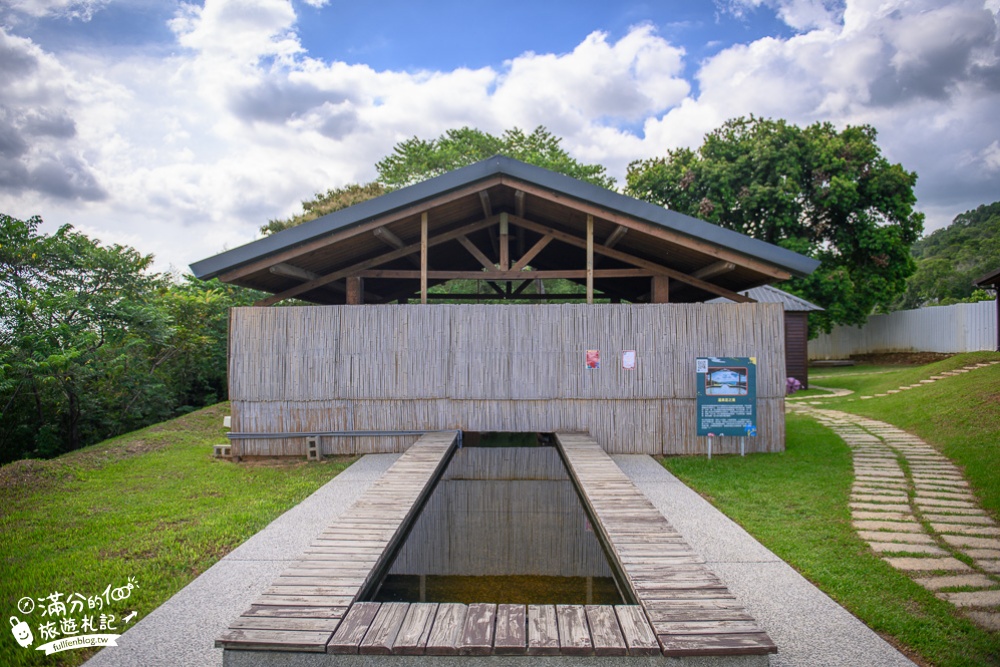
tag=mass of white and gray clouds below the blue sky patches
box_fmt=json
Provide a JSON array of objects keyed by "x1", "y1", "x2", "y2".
[{"x1": 0, "y1": 0, "x2": 1000, "y2": 268}]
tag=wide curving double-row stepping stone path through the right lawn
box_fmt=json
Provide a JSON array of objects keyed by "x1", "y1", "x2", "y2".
[{"x1": 788, "y1": 403, "x2": 1000, "y2": 630}]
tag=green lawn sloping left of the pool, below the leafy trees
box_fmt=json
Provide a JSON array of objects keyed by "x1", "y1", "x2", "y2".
[{"x1": 0, "y1": 404, "x2": 350, "y2": 665}]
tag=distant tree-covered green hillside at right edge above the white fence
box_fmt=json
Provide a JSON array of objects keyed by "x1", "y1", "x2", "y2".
[{"x1": 898, "y1": 202, "x2": 1000, "y2": 308}]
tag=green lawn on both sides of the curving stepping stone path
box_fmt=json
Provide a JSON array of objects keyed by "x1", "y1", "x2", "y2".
[{"x1": 663, "y1": 353, "x2": 1000, "y2": 667}]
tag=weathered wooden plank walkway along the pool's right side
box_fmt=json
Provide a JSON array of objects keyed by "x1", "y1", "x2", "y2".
[{"x1": 556, "y1": 433, "x2": 778, "y2": 656}]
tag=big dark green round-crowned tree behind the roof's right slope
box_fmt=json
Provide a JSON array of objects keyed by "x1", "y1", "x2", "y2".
[{"x1": 626, "y1": 116, "x2": 923, "y2": 334}]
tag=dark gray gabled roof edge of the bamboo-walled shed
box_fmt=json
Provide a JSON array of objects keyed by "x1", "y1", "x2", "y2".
[{"x1": 191, "y1": 156, "x2": 819, "y2": 280}]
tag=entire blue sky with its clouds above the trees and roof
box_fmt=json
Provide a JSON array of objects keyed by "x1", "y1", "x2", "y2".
[{"x1": 0, "y1": 0, "x2": 1000, "y2": 270}]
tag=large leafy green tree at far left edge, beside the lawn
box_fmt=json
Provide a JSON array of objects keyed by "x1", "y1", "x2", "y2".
[{"x1": 0, "y1": 215, "x2": 170, "y2": 460}]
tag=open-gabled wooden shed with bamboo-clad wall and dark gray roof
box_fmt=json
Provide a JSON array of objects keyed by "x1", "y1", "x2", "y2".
[{"x1": 191, "y1": 157, "x2": 819, "y2": 456}]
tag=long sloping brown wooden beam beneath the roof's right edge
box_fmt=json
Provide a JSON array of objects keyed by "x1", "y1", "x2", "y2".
[{"x1": 500, "y1": 175, "x2": 792, "y2": 280}]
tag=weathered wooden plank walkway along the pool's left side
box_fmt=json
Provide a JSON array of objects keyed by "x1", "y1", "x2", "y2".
[{"x1": 215, "y1": 433, "x2": 457, "y2": 653}]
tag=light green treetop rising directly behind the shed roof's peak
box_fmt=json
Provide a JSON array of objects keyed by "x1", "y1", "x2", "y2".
[{"x1": 375, "y1": 126, "x2": 615, "y2": 189}]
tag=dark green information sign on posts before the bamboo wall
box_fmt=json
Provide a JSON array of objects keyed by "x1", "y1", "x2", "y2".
[{"x1": 695, "y1": 357, "x2": 757, "y2": 458}]
